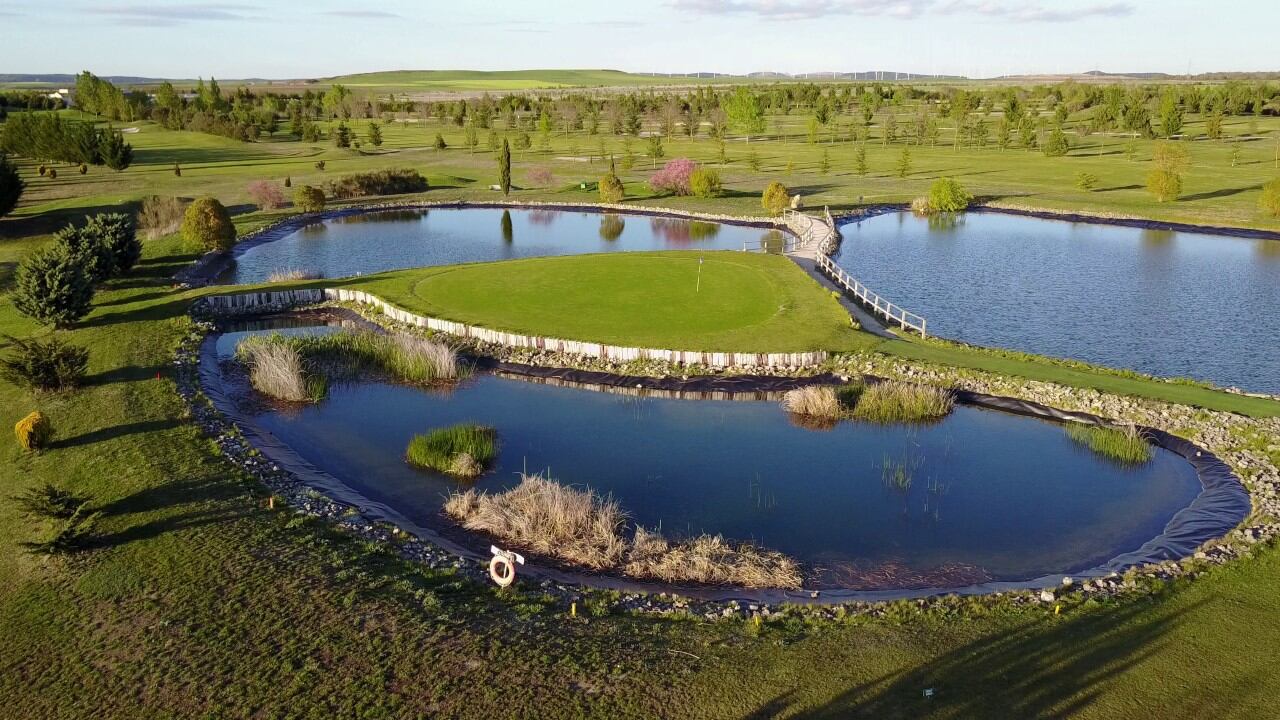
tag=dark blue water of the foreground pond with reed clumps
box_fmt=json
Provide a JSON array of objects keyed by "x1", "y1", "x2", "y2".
[{"x1": 209, "y1": 325, "x2": 1199, "y2": 589}]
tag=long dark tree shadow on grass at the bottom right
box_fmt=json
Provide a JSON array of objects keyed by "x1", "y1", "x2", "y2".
[{"x1": 762, "y1": 596, "x2": 1203, "y2": 717}]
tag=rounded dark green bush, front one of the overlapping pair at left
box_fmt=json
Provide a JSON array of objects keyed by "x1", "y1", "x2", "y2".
[{"x1": 10, "y1": 243, "x2": 93, "y2": 328}]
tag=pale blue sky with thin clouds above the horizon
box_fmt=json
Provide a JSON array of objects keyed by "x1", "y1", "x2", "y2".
[{"x1": 0, "y1": 0, "x2": 1280, "y2": 78}]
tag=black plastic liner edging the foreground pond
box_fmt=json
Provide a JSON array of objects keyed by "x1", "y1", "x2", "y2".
[{"x1": 198, "y1": 324, "x2": 1252, "y2": 603}]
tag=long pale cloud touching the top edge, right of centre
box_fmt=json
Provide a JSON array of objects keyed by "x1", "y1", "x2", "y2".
[{"x1": 669, "y1": 0, "x2": 1133, "y2": 23}]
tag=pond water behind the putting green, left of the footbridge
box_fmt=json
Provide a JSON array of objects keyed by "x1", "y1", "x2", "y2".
[{"x1": 221, "y1": 208, "x2": 782, "y2": 283}]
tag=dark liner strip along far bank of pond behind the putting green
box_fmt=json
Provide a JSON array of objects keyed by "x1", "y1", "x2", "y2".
[{"x1": 174, "y1": 201, "x2": 791, "y2": 287}]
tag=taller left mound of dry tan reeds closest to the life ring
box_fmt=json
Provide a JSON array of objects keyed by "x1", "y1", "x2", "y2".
[{"x1": 444, "y1": 475, "x2": 626, "y2": 570}]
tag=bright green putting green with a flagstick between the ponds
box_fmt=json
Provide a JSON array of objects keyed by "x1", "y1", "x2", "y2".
[{"x1": 353, "y1": 251, "x2": 878, "y2": 352}]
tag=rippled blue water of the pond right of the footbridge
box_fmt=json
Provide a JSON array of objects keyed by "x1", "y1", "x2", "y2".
[{"x1": 837, "y1": 213, "x2": 1280, "y2": 393}]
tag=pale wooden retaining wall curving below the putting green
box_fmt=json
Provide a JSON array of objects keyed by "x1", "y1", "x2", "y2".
[{"x1": 194, "y1": 288, "x2": 828, "y2": 368}]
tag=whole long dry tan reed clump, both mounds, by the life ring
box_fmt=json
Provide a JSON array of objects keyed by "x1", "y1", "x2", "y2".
[{"x1": 444, "y1": 475, "x2": 801, "y2": 588}]
